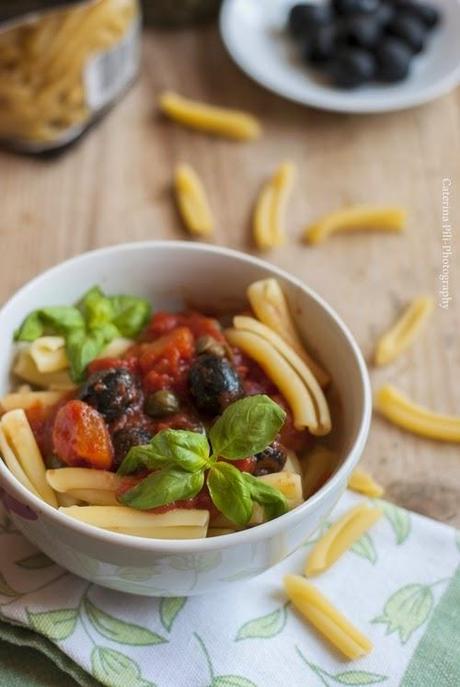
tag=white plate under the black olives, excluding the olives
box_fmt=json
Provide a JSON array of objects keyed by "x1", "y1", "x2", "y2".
[{"x1": 220, "y1": 0, "x2": 460, "y2": 113}]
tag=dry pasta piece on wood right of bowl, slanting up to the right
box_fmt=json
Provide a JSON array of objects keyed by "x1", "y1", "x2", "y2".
[{"x1": 374, "y1": 296, "x2": 434, "y2": 365}]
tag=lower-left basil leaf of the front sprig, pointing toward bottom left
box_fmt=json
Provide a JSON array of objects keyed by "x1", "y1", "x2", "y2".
[{"x1": 119, "y1": 468, "x2": 204, "y2": 510}]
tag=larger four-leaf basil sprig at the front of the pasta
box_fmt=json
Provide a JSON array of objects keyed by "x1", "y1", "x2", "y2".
[{"x1": 118, "y1": 395, "x2": 288, "y2": 527}]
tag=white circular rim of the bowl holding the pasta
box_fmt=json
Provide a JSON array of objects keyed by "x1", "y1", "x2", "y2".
[{"x1": 0, "y1": 240, "x2": 372, "y2": 554}]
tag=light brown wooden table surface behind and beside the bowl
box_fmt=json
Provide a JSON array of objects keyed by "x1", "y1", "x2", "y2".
[{"x1": 0, "y1": 26, "x2": 460, "y2": 525}]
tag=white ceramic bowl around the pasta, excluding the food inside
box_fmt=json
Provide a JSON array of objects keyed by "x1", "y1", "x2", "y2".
[{"x1": 0, "y1": 241, "x2": 371, "y2": 596}]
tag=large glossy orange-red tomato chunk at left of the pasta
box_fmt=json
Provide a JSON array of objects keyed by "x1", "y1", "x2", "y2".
[{"x1": 53, "y1": 400, "x2": 113, "y2": 470}]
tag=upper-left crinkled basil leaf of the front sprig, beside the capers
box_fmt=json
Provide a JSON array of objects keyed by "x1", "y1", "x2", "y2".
[{"x1": 118, "y1": 429, "x2": 209, "y2": 475}]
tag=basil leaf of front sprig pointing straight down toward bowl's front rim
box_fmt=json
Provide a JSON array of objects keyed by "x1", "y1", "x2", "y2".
[{"x1": 207, "y1": 461, "x2": 253, "y2": 527}]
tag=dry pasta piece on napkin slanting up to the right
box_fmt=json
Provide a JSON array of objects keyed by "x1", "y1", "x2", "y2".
[{"x1": 305, "y1": 503, "x2": 382, "y2": 576}]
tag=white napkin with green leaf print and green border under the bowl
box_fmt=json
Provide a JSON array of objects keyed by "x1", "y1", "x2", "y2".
[{"x1": 0, "y1": 493, "x2": 460, "y2": 687}]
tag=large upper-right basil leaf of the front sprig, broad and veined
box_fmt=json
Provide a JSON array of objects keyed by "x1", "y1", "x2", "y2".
[{"x1": 209, "y1": 394, "x2": 286, "y2": 460}]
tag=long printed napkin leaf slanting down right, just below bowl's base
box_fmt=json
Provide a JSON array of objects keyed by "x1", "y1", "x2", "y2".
[{"x1": 84, "y1": 598, "x2": 168, "y2": 646}]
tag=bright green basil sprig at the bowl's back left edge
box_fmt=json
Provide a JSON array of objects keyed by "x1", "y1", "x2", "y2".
[{"x1": 14, "y1": 286, "x2": 150, "y2": 382}]
